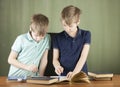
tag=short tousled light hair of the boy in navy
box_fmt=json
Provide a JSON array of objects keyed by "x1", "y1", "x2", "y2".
[{"x1": 61, "y1": 5, "x2": 81, "y2": 26}]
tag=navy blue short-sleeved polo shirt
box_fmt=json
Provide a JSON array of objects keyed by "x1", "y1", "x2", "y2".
[{"x1": 53, "y1": 28, "x2": 91, "y2": 75}]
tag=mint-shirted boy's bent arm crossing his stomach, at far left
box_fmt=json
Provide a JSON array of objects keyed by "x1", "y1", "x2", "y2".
[{"x1": 8, "y1": 51, "x2": 38, "y2": 72}]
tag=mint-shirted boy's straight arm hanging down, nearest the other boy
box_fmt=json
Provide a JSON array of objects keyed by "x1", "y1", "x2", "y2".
[{"x1": 39, "y1": 49, "x2": 48, "y2": 76}]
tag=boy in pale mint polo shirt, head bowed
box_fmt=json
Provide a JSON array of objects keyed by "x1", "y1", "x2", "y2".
[{"x1": 8, "y1": 14, "x2": 50, "y2": 77}]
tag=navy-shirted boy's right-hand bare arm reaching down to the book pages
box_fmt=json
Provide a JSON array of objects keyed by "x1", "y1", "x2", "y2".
[{"x1": 67, "y1": 44, "x2": 90, "y2": 77}]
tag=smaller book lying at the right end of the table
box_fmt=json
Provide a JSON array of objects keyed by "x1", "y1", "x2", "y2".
[{"x1": 88, "y1": 72, "x2": 113, "y2": 80}]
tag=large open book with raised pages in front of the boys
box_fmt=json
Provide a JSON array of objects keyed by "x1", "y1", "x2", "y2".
[{"x1": 26, "y1": 71, "x2": 90, "y2": 84}]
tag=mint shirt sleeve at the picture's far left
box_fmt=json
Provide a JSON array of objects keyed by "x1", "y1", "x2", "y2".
[{"x1": 11, "y1": 36, "x2": 22, "y2": 53}]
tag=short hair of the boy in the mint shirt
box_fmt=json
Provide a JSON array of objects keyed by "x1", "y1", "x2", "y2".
[{"x1": 31, "y1": 14, "x2": 49, "y2": 36}]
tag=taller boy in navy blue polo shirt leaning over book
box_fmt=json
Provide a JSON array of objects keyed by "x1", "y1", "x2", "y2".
[{"x1": 53, "y1": 5, "x2": 91, "y2": 78}]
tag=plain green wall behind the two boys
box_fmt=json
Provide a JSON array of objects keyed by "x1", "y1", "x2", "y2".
[{"x1": 0, "y1": 0, "x2": 120, "y2": 76}]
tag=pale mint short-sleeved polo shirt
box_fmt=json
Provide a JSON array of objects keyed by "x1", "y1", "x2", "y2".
[{"x1": 8, "y1": 32, "x2": 50, "y2": 76}]
